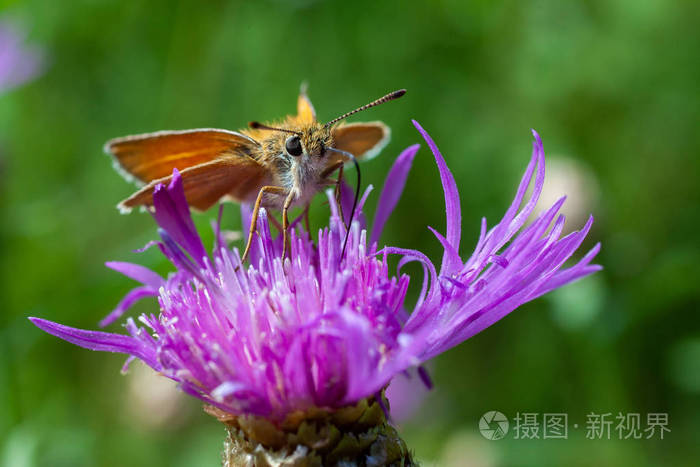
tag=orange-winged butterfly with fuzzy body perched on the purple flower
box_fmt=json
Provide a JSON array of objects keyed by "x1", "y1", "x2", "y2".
[{"x1": 104, "y1": 85, "x2": 406, "y2": 262}]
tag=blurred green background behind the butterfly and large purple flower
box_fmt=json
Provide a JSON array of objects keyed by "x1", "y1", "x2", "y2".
[{"x1": 0, "y1": 0, "x2": 700, "y2": 466}]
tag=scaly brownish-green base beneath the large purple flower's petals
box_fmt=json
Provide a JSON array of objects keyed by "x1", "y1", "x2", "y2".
[{"x1": 206, "y1": 398, "x2": 417, "y2": 467}]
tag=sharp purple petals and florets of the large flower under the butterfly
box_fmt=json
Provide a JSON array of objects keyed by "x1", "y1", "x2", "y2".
[{"x1": 30, "y1": 122, "x2": 600, "y2": 420}]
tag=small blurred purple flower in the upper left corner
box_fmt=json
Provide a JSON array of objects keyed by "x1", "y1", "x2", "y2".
[{"x1": 0, "y1": 20, "x2": 44, "y2": 94}]
